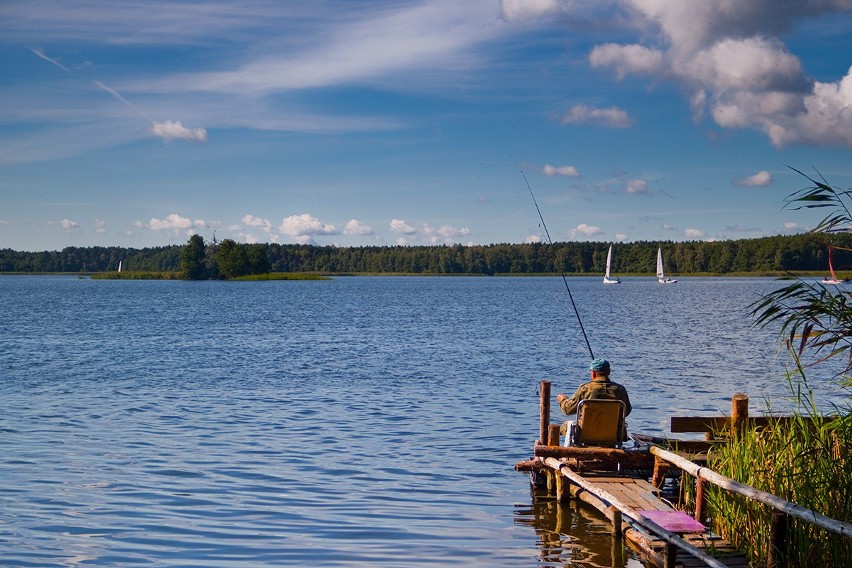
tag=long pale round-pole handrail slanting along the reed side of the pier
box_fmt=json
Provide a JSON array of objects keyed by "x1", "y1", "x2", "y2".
[{"x1": 650, "y1": 446, "x2": 852, "y2": 537}]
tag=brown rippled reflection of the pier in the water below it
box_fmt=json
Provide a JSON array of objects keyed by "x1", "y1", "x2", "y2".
[{"x1": 515, "y1": 488, "x2": 644, "y2": 568}]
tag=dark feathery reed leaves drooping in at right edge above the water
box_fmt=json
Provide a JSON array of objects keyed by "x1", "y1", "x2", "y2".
[{"x1": 752, "y1": 170, "x2": 852, "y2": 380}]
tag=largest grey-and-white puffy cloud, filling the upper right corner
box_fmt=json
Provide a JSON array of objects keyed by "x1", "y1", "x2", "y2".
[{"x1": 580, "y1": 0, "x2": 852, "y2": 147}]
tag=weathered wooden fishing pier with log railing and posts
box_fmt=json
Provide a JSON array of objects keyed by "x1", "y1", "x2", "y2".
[{"x1": 515, "y1": 381, "x2": 852, "y2": 568}]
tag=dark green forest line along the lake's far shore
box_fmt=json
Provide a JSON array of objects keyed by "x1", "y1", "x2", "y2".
[{"x1": 0, "y1": 233, "x2": 852, "y2": 279}]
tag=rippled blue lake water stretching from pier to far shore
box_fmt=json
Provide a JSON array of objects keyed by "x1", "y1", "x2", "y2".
[{"x1": 0, "y1": 276, "x2": 844, "y2": 567}]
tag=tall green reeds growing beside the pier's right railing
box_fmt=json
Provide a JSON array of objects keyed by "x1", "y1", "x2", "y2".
[{"x1": 708, "y1": 369, "x2": 852, "y2": 566}]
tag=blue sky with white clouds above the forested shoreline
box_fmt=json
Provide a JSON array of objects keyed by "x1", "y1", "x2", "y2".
[{"x1": 0, "y1": 0, "x2": 852, "y2": 251}]
